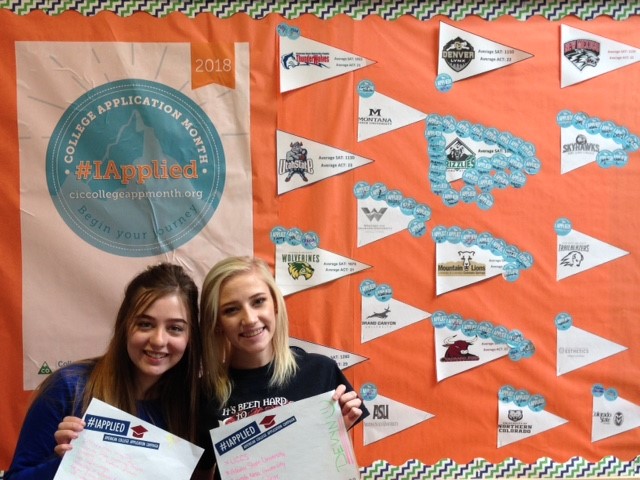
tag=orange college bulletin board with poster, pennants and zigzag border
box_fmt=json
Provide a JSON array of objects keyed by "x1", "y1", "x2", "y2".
[{"x1": 0, "y1": 0, "x2": 640, "y2": 479}]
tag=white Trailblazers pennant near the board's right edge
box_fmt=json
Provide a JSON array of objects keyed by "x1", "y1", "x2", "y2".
[{"x1": 556, "y1": 222, "x2": 629, "y2": 281}]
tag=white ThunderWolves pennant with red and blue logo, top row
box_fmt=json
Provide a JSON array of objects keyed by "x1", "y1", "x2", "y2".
[{"x1": 278, "y1": 25, "x2": 375, "y2": 93}]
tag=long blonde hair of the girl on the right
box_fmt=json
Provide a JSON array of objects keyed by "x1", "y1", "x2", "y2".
[{"x1": 200, "y1": 257, "x2": 298, "y2": 407}]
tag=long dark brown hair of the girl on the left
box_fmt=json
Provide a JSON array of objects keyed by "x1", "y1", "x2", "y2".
[{"x1": 33, "y1": 263, "x2": 202, "y2": 442}]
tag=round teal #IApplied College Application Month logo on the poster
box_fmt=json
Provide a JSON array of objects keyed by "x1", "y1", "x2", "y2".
[{"x1": 46, "y1": 80, "x2": 226, "y2": 257}]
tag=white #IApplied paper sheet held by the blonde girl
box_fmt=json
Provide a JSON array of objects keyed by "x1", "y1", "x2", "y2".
[{"x1": 210, "y1": 392, "x2": 360, "y2": 480}]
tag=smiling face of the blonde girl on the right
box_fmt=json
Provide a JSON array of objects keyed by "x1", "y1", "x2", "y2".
[{"x1": 217, "y1": 272, "x2": 276, "y2": 369}]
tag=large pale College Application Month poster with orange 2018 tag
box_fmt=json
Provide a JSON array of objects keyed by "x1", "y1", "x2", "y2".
[{"x1": 15, "y1": 41, "x2": 253, "y2": 389}]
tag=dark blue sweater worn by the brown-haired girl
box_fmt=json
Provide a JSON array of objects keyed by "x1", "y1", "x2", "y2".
[{"x1": 4, "y1": 364, "x2": 166, "y2": 480}]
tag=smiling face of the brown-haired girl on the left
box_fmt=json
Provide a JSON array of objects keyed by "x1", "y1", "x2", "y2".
[{"x1": 127, "y1": 293, "x2": 190, "y2": 398}]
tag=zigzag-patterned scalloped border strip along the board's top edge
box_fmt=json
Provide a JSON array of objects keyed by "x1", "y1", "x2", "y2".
[{"x1": 0, "y1": 0, "x2": 640, "y2": 20}]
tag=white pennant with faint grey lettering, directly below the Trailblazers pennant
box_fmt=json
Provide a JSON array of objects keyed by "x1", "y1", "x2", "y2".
[{"x1": 556, "y1": 313, "x2": 627, "y2": 376}]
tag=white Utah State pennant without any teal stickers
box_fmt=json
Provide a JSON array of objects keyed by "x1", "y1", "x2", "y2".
[{"x1": 276, "y1": 130, "x2": 373, "y2": 195}]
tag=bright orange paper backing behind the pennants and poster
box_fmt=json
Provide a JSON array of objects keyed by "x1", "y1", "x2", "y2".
[{"x1": 0, "y1": 10, "x2": 640, "y2": 469}]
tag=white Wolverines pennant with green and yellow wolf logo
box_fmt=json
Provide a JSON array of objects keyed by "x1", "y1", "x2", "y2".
[{"x1": 275, "y1": 244, "x2": 371, "y2": 296}]
